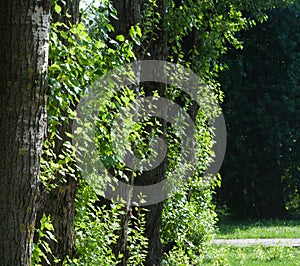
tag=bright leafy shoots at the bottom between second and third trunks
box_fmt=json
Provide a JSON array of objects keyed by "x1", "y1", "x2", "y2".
[{"x1": 65, "y1": 184, "x2": 123, "y2": 265}]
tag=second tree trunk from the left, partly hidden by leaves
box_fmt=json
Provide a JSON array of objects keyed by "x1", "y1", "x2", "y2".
[{"x1": 37, "y1": 0, "x2": 79, "y2": 265}]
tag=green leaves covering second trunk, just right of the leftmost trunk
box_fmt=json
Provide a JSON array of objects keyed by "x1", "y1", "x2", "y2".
[{"x1": 41, "y1": 16, "x2": 94, "y2": 187}]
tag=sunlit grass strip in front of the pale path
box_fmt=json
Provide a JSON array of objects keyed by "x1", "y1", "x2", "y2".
[{"x1": 201, "y1": 246, "x2": 300, "y2": 266}]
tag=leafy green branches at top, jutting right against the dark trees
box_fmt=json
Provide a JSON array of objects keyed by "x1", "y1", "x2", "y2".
[{"x1": 166, "y1": 1, "x2": 248, "y2": 78}]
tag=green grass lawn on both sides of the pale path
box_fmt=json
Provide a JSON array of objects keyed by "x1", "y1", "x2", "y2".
[{"x1": 163, "y1": 220, "x2": 300, "y2": 266}]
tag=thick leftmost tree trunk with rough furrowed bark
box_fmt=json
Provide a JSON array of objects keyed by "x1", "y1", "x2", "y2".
[{"x1": 0, "y1": 0, "x2": 50, "y2": 266}]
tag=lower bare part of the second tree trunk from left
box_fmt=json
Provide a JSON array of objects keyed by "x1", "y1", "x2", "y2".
[{"x1": 36, "y1": 123, "x2": 77, "y2": 265}]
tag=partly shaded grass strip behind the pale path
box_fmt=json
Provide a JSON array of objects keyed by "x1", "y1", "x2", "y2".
[{"x1": 216, "y1": 220, "x2": 300, "y2": 240}]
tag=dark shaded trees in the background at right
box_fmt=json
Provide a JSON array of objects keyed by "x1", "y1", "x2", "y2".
[{"x1": 219, "y1": 3, "x2": 300, "y2": 218}]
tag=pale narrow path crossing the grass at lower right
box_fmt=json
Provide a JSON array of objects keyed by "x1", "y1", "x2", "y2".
[{"x1": 212, "y1": 238, "x2": 300, "y2": 247}]
